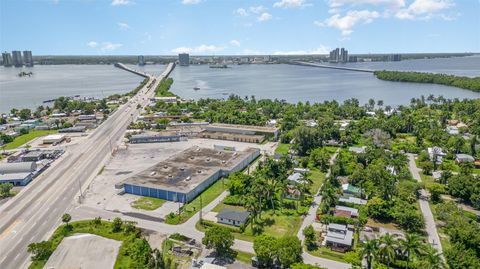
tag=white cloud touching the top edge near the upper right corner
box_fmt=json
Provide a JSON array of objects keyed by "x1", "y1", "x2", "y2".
[{"x1": 395, "y1": 0, "x2": 455, "y2": 20}]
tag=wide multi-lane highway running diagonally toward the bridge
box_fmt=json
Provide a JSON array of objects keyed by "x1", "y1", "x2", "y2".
[{"x1": 0, "y1": 64, "x2": 174, "y2": 269}]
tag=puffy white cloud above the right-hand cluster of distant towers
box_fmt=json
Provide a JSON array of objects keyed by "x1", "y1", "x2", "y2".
[{"x1": 314, "y1": 10, "x2": 380, "y2": 36}]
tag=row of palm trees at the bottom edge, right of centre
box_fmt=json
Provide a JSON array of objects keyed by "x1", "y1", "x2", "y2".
[{"x1": 360, "y1": 233, "x2": 445, "y2": 269}]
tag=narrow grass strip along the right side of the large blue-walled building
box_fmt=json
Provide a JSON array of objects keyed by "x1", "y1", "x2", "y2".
[{"x1": 165, "y1": 178, "x2": 228, "y2": 225}]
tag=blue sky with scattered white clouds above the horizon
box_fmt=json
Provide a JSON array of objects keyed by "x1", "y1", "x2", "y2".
[{"x1": 0, "y1": 0, "x2": 480, "y2": 55}]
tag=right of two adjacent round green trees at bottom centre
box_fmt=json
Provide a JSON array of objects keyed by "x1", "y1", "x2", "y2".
[{"x1": 277, "y1": 236, "x2": 303, "y2": 268}]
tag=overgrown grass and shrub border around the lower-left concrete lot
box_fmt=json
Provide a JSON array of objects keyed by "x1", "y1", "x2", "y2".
[{"x1": 28, "y1": 220, "x2": 144, "y2": 269}]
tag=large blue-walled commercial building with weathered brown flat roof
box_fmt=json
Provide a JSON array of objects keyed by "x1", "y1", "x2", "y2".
[{"x1": 123, "y1": 147, "x2": 260, "y2": 203}]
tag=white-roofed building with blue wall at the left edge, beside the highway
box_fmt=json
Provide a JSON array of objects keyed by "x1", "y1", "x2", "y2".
[{"x1": 0, "y1": 162, "x2": 37, "y2": 186}]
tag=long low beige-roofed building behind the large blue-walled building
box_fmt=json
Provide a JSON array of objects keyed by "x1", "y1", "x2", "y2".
[{"x1": 205, "y1": 123, "x2": 280, "y2": 141}]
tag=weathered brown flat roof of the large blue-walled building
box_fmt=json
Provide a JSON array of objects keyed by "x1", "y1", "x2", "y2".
[{"x1": 124, "y1": 147, "x2": 259, "y2": 193}]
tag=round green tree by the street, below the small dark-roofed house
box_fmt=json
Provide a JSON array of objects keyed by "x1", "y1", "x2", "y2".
[{"x1": 202, "y1": 226, "x2": 235, "y2": 257}]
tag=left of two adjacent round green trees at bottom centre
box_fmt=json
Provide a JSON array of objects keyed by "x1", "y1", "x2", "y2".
[{"x1": 253, "y1": 234, "x2": 278, "y2": 268}]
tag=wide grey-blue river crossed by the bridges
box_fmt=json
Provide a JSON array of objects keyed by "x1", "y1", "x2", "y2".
[{"x1": 0, "y1": 56, "x2": 480, "y2": 112}]
